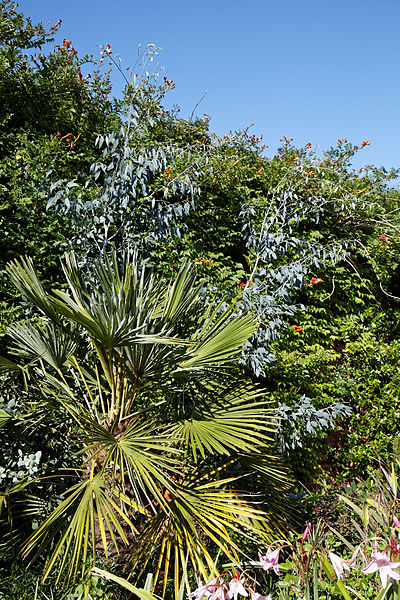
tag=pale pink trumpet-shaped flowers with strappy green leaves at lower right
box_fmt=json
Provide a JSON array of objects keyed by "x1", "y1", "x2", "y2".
[{"x1": 242, "y1": 472, "x2": 400, "y2": 600}]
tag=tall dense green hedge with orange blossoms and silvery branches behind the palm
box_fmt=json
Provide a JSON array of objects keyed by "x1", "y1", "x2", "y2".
[{"x1": 0, "y1": 1, "x2": 400, "y2": 598}]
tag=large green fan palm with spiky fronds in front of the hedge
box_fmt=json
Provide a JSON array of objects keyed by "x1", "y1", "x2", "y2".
[{"x1": 0, "y1": 254, "x2": 285, "y2": 592}]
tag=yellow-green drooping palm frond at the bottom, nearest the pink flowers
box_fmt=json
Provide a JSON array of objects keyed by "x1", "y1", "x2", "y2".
[{"x1": 133, "y1": 472, "x2": 267, "y2": 589}]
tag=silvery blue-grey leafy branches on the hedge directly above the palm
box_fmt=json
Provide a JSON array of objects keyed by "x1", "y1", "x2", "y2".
[{"x1": 47, "y1": 122, "x2": 207, "y2": 255}]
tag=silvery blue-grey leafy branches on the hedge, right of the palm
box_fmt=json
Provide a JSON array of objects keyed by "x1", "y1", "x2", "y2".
[{"x1": 236, "y1": 160, "x2": 354, "y2": 376}]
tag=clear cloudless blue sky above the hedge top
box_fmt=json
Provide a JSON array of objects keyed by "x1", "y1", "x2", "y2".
[{"x1": 19, "y1": 0, "x2": 400, "y2": 173}]
